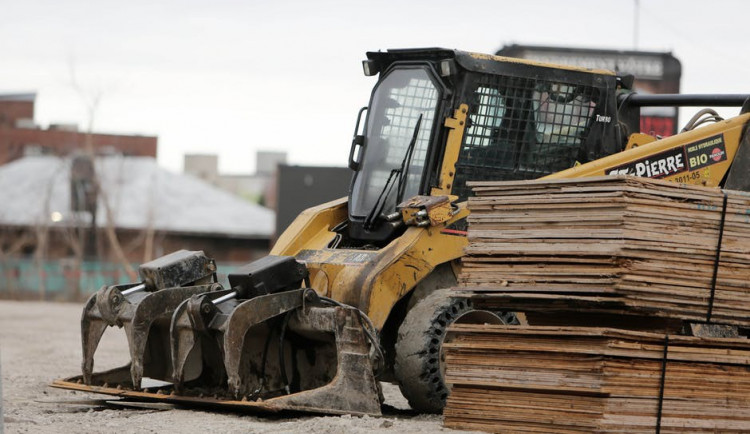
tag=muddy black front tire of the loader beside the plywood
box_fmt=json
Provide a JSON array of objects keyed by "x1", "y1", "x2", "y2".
[{"x1": 394, "y1": 289, "x2": 515, "y2": 413}]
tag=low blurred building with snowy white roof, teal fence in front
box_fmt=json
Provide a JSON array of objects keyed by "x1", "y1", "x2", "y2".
[{"x1": 0, "y1": 156, "x2": 274, "y2": 299}]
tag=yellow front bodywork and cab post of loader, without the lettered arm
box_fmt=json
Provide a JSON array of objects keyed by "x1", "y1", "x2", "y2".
[{"x1": 271, "y1": 105, "x2": 476, "y2": 329}]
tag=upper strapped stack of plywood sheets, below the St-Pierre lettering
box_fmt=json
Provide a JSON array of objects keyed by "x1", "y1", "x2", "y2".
[{"x1": 459, "y1": 176, "x2": 750, "y2": 326}]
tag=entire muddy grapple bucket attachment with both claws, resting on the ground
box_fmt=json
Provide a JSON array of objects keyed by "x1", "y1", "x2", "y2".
[{"x1": 62, "y1": 252, "x2": 380, "y2": 415}]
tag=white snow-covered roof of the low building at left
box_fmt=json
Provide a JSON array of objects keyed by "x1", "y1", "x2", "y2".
[{"x1": 0, "y1": 156, "x2": 275, "y2": 238}]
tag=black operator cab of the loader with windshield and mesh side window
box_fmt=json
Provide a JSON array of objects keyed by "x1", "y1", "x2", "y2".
[{"x1": 348, "y1": 48, "x2": 623, "y2": 246}]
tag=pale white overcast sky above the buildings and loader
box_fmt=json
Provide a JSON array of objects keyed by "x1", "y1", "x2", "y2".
[{"x1": 0, "y1": 0, "x2": 750, "y2": 173}]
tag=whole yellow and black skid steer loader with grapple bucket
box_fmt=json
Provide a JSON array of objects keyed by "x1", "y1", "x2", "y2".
[{"x1": 54, "y1": 49, "x2": 750, "y2": 415}]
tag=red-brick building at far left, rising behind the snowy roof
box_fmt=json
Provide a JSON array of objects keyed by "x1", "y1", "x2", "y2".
[{"x1": 0, "y1": 93, "x2": 157, "y2": 165}]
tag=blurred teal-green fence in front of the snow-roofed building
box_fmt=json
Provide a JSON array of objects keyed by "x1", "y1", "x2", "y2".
[{"x1": 0, "y1": 258, "x2": 239, "y2": 300}]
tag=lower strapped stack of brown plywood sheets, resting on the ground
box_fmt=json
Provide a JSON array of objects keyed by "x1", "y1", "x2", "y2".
[{"x1": 444, "y1": 324, "x2": 750, "y2": 433}]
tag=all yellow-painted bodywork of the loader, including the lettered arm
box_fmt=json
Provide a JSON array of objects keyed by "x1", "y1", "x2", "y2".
[{"x1": 271, "y1": 114, "x2": 750, "y2": 328}]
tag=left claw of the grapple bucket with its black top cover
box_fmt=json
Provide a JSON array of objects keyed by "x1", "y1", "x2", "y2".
[{"x1": 81, "y1": 250, "x2": 221, "y2": 389}]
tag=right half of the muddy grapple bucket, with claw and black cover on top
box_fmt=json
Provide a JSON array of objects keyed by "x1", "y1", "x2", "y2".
[{"x1": 171, "y1": 257, "x2": 380, "y2": 415}]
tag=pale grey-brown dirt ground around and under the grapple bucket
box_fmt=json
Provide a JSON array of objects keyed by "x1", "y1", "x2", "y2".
[{"x1": 0, "y1": 301, "x2": 478, "y2": 434}]
